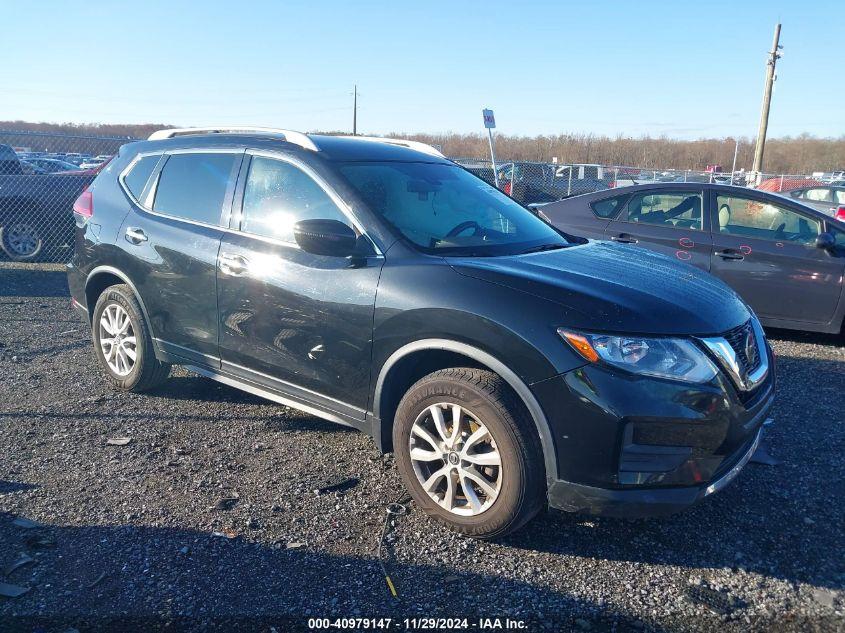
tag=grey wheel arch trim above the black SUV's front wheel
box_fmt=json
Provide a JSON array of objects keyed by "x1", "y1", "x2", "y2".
[{"x1": 373, "y1": 338, "x2": 557, "y2": 484}]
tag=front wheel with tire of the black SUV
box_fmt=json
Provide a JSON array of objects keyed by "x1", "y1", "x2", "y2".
[{"x1": 393, "y1": 367, "x2": 546, "y2": 539}]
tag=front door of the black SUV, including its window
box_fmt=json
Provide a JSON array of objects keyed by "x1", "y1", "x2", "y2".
[{"x1": 218, "y1": 153, "x2": 383, "y2": 419}]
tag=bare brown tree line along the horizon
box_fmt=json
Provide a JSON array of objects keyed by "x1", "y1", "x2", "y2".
[{"x1": 0, "y1": 121, "x2": 845, "y2": 174}]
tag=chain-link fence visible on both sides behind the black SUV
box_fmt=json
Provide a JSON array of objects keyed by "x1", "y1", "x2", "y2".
[{"x1": 0, "y1": 130, "x2": 832, "y2": 263}]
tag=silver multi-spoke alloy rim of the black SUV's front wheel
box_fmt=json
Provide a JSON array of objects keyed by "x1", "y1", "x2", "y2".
[{"x1": 409, "y1": 402, "x2": 502, "y2": 516}]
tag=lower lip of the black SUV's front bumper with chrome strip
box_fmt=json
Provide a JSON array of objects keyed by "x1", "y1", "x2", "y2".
[{"x1": 548, "y1": 418, "x2": 763, "y2": 519}]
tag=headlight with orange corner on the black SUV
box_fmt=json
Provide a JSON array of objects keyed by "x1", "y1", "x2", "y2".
[{"x1": 558, "y1": 328, "x2": 718, "y2": 383}]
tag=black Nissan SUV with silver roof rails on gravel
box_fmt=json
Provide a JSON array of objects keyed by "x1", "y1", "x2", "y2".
[{"x1": 68, "y1": 129, "x2": 774, "y2": 537}]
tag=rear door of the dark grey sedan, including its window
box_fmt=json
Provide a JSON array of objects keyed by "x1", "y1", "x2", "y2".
[{"x1": 605, "y1": 187, "x2": 713, "y2": 270}]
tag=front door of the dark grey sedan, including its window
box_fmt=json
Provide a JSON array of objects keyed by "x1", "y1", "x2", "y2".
[{"x1": 711, "y1": 191, "x2": 845, "y2": 323}]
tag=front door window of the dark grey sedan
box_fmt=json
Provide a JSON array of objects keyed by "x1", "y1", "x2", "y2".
[{"x1": 716, "y1": 196, "x2": 821, "y2": 246}]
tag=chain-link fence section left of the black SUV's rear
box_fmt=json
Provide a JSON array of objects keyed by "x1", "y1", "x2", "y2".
[{"x1": 0, "y1": 130, "x2": 133, "y2": 263}]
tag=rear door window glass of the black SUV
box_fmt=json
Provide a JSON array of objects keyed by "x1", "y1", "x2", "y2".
[{"x1": 153, "y1": 152, "x2": 240, "y2": 225}]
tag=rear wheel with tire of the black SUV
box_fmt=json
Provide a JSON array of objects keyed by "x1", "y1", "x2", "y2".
[{"x1": 91, "y1": 284, "x2": 170, "y2": 392}]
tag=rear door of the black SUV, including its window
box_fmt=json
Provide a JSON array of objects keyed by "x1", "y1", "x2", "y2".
[{"x1": 118, "y1": 150, "x2": 243, "y2": 366}]
